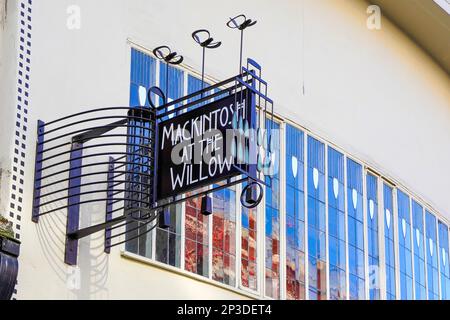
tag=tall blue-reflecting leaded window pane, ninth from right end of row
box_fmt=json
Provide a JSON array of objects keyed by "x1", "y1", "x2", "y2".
[{"x1": 307, "y1": 136, "x2": 327, "y2": 300}]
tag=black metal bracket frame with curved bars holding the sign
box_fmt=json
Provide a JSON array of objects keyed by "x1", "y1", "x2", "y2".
[{"x1": 32, "y1": 59, "x2": 273, "y2": 265}]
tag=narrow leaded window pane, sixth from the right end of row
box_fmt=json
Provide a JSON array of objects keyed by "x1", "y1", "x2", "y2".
[{"x1": 366, "y1": 173, "x2": 381, "y2": 300}]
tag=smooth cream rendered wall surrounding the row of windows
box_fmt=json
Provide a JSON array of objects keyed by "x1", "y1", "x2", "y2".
[{"x1": 12, "y1": 0, "x2": 450, "y2": 299}]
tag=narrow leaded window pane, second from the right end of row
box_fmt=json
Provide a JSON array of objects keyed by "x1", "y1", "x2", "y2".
[{"x1": 425, "y1": 210, "x2": 439, "y2": 300}]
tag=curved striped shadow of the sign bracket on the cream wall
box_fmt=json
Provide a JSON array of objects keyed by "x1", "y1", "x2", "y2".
[{"x1": 36, "y1": 165, "x2": 109, "y2": 299}]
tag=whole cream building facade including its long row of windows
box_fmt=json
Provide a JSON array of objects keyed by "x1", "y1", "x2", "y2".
[{"x1": 0, "y1": 0, "x2": 450, "y2": 300}]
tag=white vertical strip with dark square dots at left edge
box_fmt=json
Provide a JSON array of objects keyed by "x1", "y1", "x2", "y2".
[{"x1": 9, "y1": 0, "x2": 33, "y2": 299}]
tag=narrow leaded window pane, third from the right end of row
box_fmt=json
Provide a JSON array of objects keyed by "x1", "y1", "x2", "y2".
[{"x1": 412, "y1": 200, "x2": 427, "y2": 300}]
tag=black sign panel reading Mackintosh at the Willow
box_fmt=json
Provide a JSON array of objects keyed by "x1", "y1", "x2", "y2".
[{"x1": 156, "y1": 90, "x2": 256, "y2": 200}]
